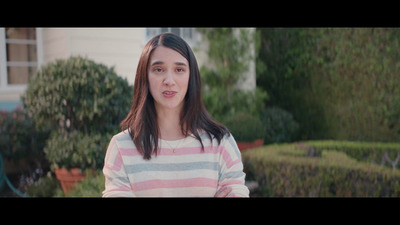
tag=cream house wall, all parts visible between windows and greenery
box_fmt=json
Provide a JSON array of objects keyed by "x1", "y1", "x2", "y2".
[{"x1": 0, "y1": 28, "x2": 255, "y2": 106}]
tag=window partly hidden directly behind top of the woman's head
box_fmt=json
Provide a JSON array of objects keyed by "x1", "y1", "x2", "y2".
[{"x1": 145, "y1": 27, "x2": 199, "y2": 48}]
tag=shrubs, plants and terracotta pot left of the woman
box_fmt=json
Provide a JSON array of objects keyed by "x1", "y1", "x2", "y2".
[{"x1": 0, "y1": 57, "x2": 133, "y2": 197}]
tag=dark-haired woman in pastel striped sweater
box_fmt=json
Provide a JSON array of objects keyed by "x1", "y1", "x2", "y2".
[{"x1": 103, "y1": 33, "x2": 249, "y2": 197}]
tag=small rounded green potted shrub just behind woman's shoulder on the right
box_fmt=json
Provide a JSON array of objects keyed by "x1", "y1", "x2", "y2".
[{"x1": 224, "y1": 113, "x2": 264, "y2": 142}]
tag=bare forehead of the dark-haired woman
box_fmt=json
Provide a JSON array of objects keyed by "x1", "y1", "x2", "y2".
[{"x1": 150, "y1": 46, "x2": 188, "y2": 65}]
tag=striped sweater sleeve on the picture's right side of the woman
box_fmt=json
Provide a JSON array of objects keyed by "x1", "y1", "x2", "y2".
[{"x1": 215, "y1": 134, "x2": 249, "y2": 197}]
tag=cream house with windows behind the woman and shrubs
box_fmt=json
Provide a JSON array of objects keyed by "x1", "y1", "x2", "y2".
[{"x1": 0, "y1": 27, "x2": 255, "y2": 111}]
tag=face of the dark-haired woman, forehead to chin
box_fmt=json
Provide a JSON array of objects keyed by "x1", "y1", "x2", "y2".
[{"x1": 148, "y1": 46, "x2": 190, "y2": 112}]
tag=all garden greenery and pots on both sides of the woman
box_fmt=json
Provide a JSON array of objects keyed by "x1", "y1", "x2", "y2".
[{"x1": 0, "y1": 28, "x2": 400, "y2": 197}]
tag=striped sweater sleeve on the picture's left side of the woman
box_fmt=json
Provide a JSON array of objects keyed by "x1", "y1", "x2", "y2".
[{"x1": 103, "y1": 137, "x2": 135, "y2": 197}]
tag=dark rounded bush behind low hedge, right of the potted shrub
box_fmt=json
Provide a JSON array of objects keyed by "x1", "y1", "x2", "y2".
[{"x1": 261, "y1": 107, "x2": 299, "y2": 144}]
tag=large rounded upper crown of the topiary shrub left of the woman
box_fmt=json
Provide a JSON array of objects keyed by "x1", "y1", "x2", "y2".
[{"x1": 22, "y1": 57, "x2": 133, "y2": 133}]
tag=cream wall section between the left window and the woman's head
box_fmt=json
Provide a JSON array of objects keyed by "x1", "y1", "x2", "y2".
[{"x1": 43, "y1": 28, "x2": 145, "y2": 84}]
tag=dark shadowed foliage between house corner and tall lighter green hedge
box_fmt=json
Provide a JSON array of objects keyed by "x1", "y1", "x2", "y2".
[{"x1": 257, "y1": 28, "x2": 327, "y2": 139}]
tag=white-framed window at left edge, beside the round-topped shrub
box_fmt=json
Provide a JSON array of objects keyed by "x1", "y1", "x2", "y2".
[{"x1": 0, "y1": 27, "x2": 39, "y2": 88}]
